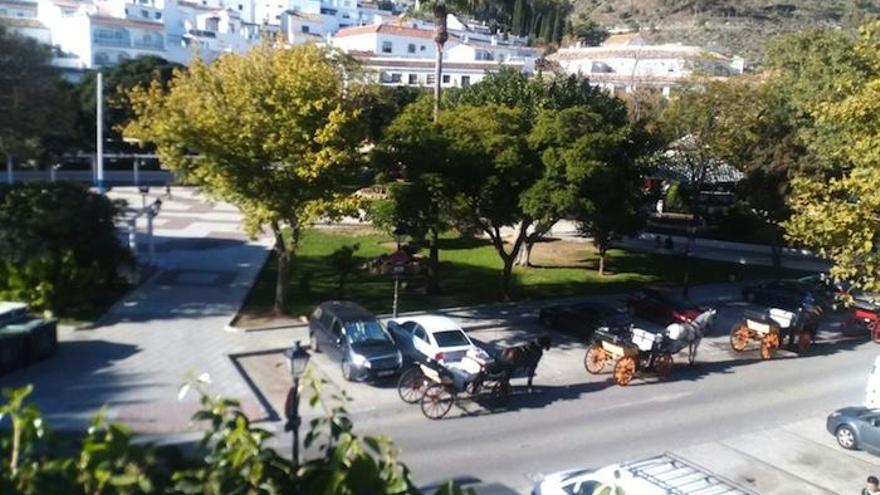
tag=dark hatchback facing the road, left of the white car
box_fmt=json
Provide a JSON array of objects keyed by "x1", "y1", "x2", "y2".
[{"x1": 309, "y1": 301, "x2": 403, "y2": 381}]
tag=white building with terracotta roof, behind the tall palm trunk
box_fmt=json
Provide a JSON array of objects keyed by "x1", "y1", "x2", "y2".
[{"x1": 331, "y1": 23, "x2": 539, "y2": 87}]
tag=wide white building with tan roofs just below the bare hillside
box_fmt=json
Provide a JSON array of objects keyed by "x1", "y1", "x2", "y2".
[{"x1": 548, "y1": 33, "x2": 745, "y2": 96}]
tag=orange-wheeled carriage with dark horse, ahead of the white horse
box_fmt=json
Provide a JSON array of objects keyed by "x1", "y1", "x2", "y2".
[{"x1": 730, "y1": 307, "x2": 819, "y2": 359}]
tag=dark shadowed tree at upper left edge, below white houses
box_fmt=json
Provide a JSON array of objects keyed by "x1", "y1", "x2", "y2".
[{"x1": 0, "y1": 22, "x2": 73, "y2": 171}]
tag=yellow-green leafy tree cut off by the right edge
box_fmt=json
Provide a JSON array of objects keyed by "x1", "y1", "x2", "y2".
[{"x1": 785, "y1": 21, "x2": 880, "y2": 291}]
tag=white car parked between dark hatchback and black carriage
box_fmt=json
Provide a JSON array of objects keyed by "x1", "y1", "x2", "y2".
[{"x1": 388, "y1": 315, "x2": 489, "y2": 363}]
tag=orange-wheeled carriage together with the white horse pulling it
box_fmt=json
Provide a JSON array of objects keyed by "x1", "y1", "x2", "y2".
[{"x1": 584, "y1": 309, "x2": 716, "y2": 386}]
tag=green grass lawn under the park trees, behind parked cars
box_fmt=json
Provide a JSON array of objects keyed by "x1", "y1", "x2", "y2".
[{"x1": 238, "y1": 228, "x2": 804, "y2": 327}]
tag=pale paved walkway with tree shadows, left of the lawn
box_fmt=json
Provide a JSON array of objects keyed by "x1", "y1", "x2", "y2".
[{"x1": 0, "y1": 188, "x2": 300, "y2": 433}]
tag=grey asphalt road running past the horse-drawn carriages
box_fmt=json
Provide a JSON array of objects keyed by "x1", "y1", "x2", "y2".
[{"x1": 290, "y1": 287, "x2": 880, "y2": 494}]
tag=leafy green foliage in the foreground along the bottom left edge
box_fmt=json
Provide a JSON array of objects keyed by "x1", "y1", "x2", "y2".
[{"x1": 0, "y1": 371, "x2": 474, "y2": 495}]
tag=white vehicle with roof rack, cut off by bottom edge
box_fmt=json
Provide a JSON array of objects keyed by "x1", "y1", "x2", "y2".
[{"x1": 532, "y1": 453, "x2": 755, "y2": 495}]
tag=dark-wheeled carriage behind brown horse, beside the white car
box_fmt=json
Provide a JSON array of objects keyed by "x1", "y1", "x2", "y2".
[{"x1": 397, "y1": 354, "x2": 513, "y2": 419}]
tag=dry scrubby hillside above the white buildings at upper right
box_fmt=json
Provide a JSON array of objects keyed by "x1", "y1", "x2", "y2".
[{"x1": 572, "y1": 0, "x2": 880, "y2": 62}]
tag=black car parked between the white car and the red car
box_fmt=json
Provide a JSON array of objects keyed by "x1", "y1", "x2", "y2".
[{"x1": 538, "y1": 302, "x2": 632, "y2": 337}]
